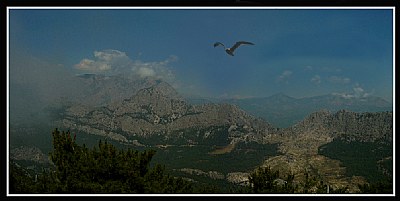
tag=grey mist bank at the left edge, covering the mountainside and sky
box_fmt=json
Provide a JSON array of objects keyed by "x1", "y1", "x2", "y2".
[{"x1": 9, "y1": 49, "x2": 83, "y2": 125}]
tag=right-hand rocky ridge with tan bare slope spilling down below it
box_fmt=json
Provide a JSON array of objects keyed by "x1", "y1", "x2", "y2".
[{"x1": 264, "y1": 110, "x2": 393, "y2": 192}]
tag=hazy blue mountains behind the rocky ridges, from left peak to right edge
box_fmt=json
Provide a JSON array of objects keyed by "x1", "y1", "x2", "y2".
[{"x1": 74, "y1": 74, "x2": 392, "y2": 128}]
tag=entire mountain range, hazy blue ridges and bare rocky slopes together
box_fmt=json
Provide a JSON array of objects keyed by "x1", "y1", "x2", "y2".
[{"x1": 10, "y1": 74, "x2": 393, "y2": 191}]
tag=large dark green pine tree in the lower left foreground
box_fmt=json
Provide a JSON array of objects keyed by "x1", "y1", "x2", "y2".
[{"x1": 42, "y1": 129, "x2": 193, "y2": 193}]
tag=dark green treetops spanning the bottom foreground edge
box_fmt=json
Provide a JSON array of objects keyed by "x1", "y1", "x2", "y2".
[{"x1": 9, "y1": 128, "x2": 392, "y2": 194}]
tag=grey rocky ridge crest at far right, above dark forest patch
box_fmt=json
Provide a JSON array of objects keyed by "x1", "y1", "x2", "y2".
[{"x1": 285, "y1": 110, "x2": 393, "y2": 143}]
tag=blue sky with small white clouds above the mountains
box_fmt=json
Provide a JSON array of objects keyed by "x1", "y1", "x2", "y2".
[{"x1": 8, "y1": 7, "x2": 393, "y2": 102}]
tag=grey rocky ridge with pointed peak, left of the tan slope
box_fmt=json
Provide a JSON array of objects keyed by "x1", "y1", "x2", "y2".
[{"x1": 62, "y1": 80, "x2": 275, "y2": 142}]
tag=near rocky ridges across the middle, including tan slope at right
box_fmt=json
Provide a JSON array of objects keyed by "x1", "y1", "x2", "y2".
[{"x1": 10, "y1": 76, "x2": 393, "y2": 193}]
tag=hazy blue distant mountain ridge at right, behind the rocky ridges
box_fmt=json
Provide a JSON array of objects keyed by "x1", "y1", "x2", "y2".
[{"x1": 221, "y1": 93, "x2": 392, "y2": 128}]
